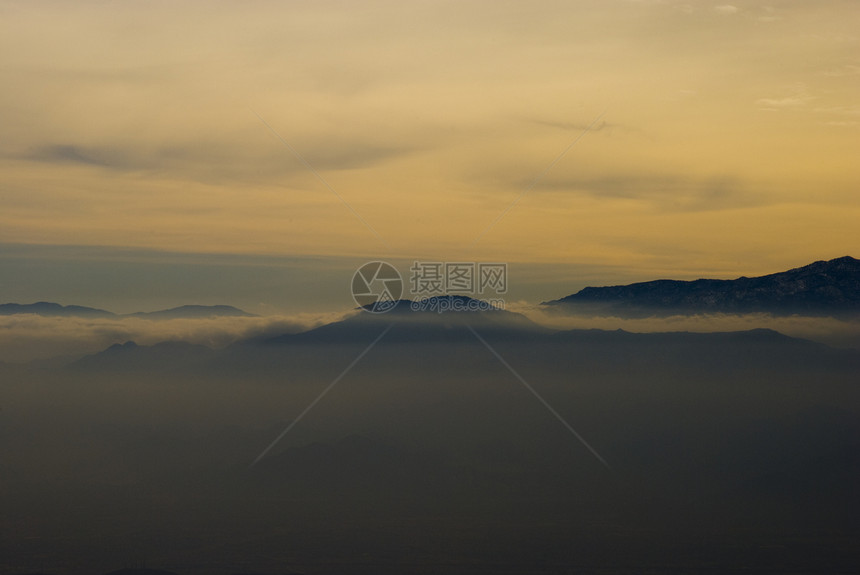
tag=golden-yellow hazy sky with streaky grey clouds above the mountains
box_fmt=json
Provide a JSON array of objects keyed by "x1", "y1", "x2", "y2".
[{"x1": 0, "y1": 0, "x2": 860, "y2": 313}]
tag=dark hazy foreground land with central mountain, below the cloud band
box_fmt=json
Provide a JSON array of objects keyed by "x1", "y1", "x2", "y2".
[{"x1": 0, "y1": 306, "x2": 860, "y2": 575}]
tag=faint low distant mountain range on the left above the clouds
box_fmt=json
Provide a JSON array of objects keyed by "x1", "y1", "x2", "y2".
[{"x1": 0, "y1": 301, "x2": 256, "y2": 319}]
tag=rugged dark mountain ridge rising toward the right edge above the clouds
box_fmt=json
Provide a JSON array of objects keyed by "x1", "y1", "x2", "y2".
[{"x1": 542, "y1": 256, "x2": 860, "y2": 317}]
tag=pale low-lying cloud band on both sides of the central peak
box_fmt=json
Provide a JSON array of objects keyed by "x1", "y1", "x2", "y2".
[{"x1": 5, "y1": 302, "x2": 860, "y2": 363}]
